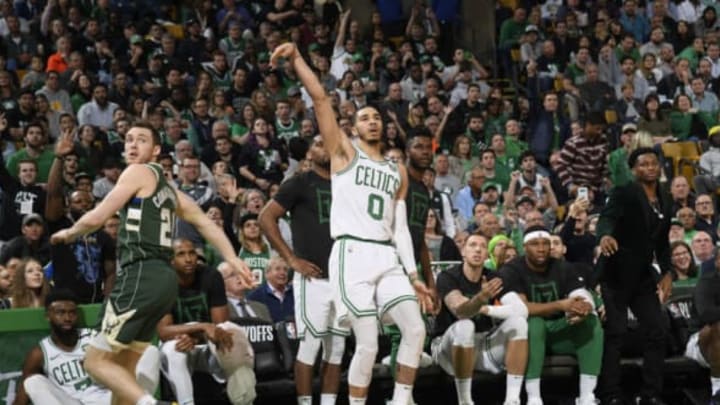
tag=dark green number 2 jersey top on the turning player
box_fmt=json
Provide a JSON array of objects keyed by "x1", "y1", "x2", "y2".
[{"x1": 118, "y1": 163, "x2": 177, "y2": 266}]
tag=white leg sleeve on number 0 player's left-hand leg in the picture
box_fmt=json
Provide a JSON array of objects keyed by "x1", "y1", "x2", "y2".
[{"x1": 348, "y1": 317, "x2": 378, "y2": 387}]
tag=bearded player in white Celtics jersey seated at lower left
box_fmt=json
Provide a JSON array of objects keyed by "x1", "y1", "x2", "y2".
[{"x1": 13, "y1": 290, "x2": 159, "y2": 405}]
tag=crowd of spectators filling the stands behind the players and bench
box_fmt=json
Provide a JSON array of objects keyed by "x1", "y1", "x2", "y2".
[{"x1": 0, "y1": 0, "x2": 720, "y2": 400}]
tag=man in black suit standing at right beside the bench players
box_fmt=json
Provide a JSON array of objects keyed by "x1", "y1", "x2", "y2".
[{"x1": 597, "y1": 148, "x2": 673, "y2": 405}]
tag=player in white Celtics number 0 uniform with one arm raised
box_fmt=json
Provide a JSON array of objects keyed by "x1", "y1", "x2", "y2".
[{"x1": 270, "y1": 43, "x2": 433, "y2": 405}]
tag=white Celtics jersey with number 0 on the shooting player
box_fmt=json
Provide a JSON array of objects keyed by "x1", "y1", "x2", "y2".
[{"x1": 330, "y1": 146, "x2": 401, "y2": 242}]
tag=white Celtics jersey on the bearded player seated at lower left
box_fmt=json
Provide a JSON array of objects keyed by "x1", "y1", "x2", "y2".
[{"x1": 40, "y1": 329, "x2": 105, "y2": 402}]
